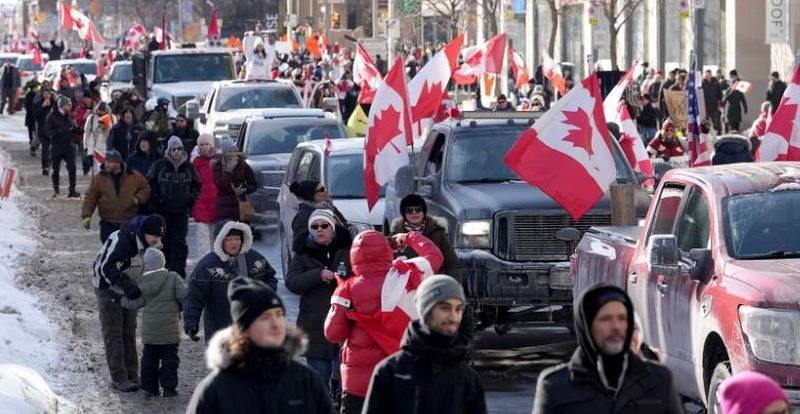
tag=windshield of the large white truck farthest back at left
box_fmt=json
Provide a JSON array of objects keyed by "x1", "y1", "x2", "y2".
[{"x1": 153, "y1": 53, "x2": 233, "y2": 83}]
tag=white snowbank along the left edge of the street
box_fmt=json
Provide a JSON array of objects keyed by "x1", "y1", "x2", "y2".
[{"x1": 0, "y1": 130, "x2": 70, "y2": 414}]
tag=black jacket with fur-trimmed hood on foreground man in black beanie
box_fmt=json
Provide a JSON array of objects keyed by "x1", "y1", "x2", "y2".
[{"x1": 186, "y1": 324, "x2": 331, "y2": 414}]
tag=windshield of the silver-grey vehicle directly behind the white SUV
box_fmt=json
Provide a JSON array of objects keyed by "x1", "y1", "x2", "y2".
[{"x1": 247, "y1": 123, "x2": 346, "y2": 155}]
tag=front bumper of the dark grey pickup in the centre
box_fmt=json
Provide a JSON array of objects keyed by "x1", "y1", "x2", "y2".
[{"x1": 456, "y1": 249, "x2": 573, "y2": 306}]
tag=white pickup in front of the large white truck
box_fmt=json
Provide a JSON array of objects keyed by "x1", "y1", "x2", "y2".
[{"x1": 192, "y1": 80, "x2": 303, "y2": 139}]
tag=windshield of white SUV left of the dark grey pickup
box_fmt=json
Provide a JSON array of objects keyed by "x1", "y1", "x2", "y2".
[{"x1": 325, "y1": 153, "x2": 386, "y2": 199}]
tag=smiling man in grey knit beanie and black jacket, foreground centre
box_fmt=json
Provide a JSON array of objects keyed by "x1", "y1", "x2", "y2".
[{"x1": 362, "y1": 275, "x2": 487, "y2": 414}]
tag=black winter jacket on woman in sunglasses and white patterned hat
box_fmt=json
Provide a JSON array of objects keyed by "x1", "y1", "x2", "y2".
[{"x1": 284, "y1": 226, "x2": 353, "y2": 360}]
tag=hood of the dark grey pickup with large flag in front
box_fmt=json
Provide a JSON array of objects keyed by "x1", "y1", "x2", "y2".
[{"x1": 448, "y1": 181, "x2": 611, "y2": 220}]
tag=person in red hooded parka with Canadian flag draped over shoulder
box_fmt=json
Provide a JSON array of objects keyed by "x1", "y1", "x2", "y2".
[{"x1": 324, "y1": 230, "x2": 444, "y2": 413}]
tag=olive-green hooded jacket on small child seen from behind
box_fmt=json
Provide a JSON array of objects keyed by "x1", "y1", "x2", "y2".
[{"x1": 120, "y1": 268, "x2": 186, "y2": 345}]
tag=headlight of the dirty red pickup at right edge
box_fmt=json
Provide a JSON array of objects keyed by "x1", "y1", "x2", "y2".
[{"x1": 739, "y1": 306, "x2": 800, "y2": 365}]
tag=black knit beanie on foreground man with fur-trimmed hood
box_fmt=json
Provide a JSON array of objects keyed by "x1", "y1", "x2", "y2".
[{"x1": 228, "y1": 277, "x2": 286, "y2": 329}]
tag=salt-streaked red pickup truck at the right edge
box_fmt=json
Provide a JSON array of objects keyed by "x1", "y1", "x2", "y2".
[{"x1": 571, "y1": 162, "x2": 800, "y2": 413}]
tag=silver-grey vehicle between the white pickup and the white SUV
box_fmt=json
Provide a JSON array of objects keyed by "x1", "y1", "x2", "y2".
[{"x1": 236, "y1": 108, "x2": 347, "y2": 222}]
